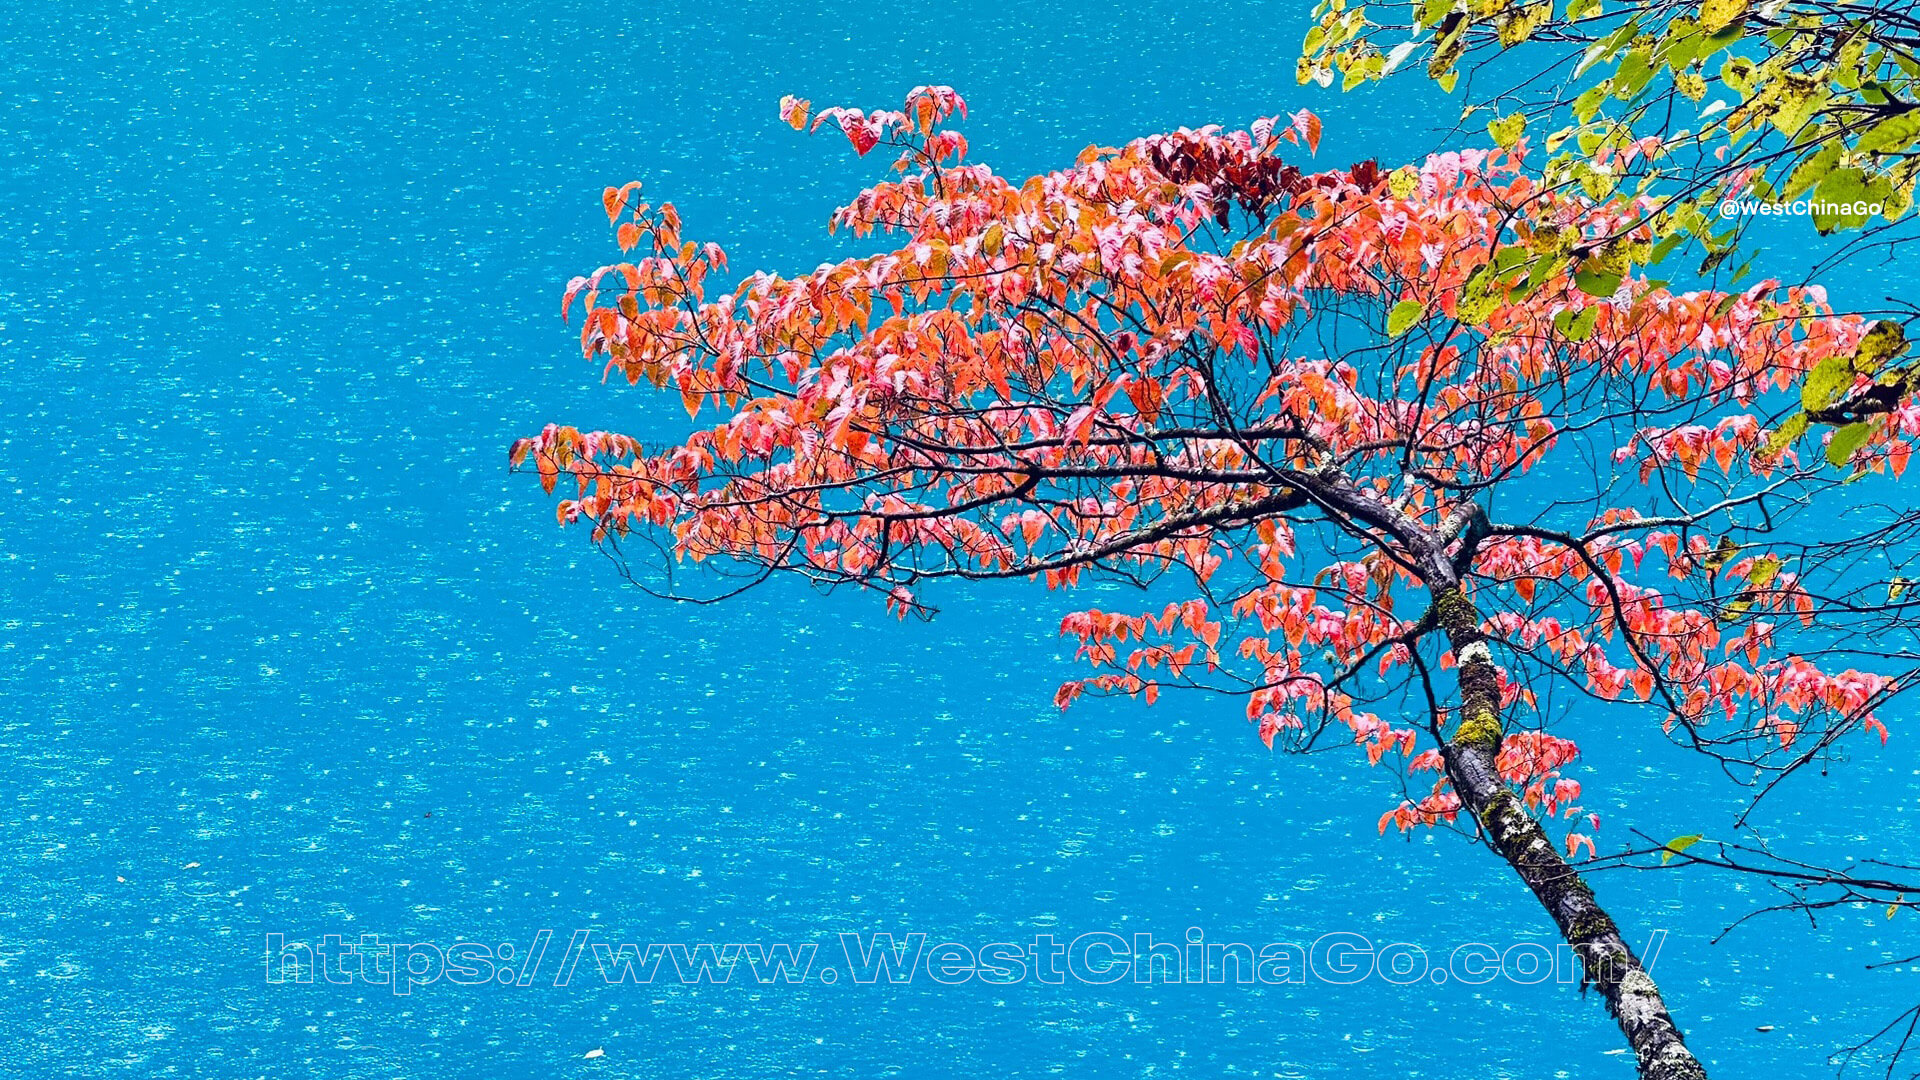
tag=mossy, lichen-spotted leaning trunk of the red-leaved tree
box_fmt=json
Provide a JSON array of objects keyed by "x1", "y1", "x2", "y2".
[{"x1": 1434, "y1": 586, "x2": 1707, "y2": 1080}]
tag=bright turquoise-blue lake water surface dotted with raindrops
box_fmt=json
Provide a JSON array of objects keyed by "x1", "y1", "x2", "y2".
[{"x1": 0, "y1": 0, "x2": 1920, "y2": 1080}]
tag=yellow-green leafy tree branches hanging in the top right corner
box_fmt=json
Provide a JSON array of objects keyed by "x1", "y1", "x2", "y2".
[{"x1": 1300, "y1": 0, "x2": 1920, "y2": 279}]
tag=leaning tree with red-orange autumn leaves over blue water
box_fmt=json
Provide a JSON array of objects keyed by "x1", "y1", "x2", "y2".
[{"x1": 509, "y1": 86, "x2": 1920, "y2": 1078}]
